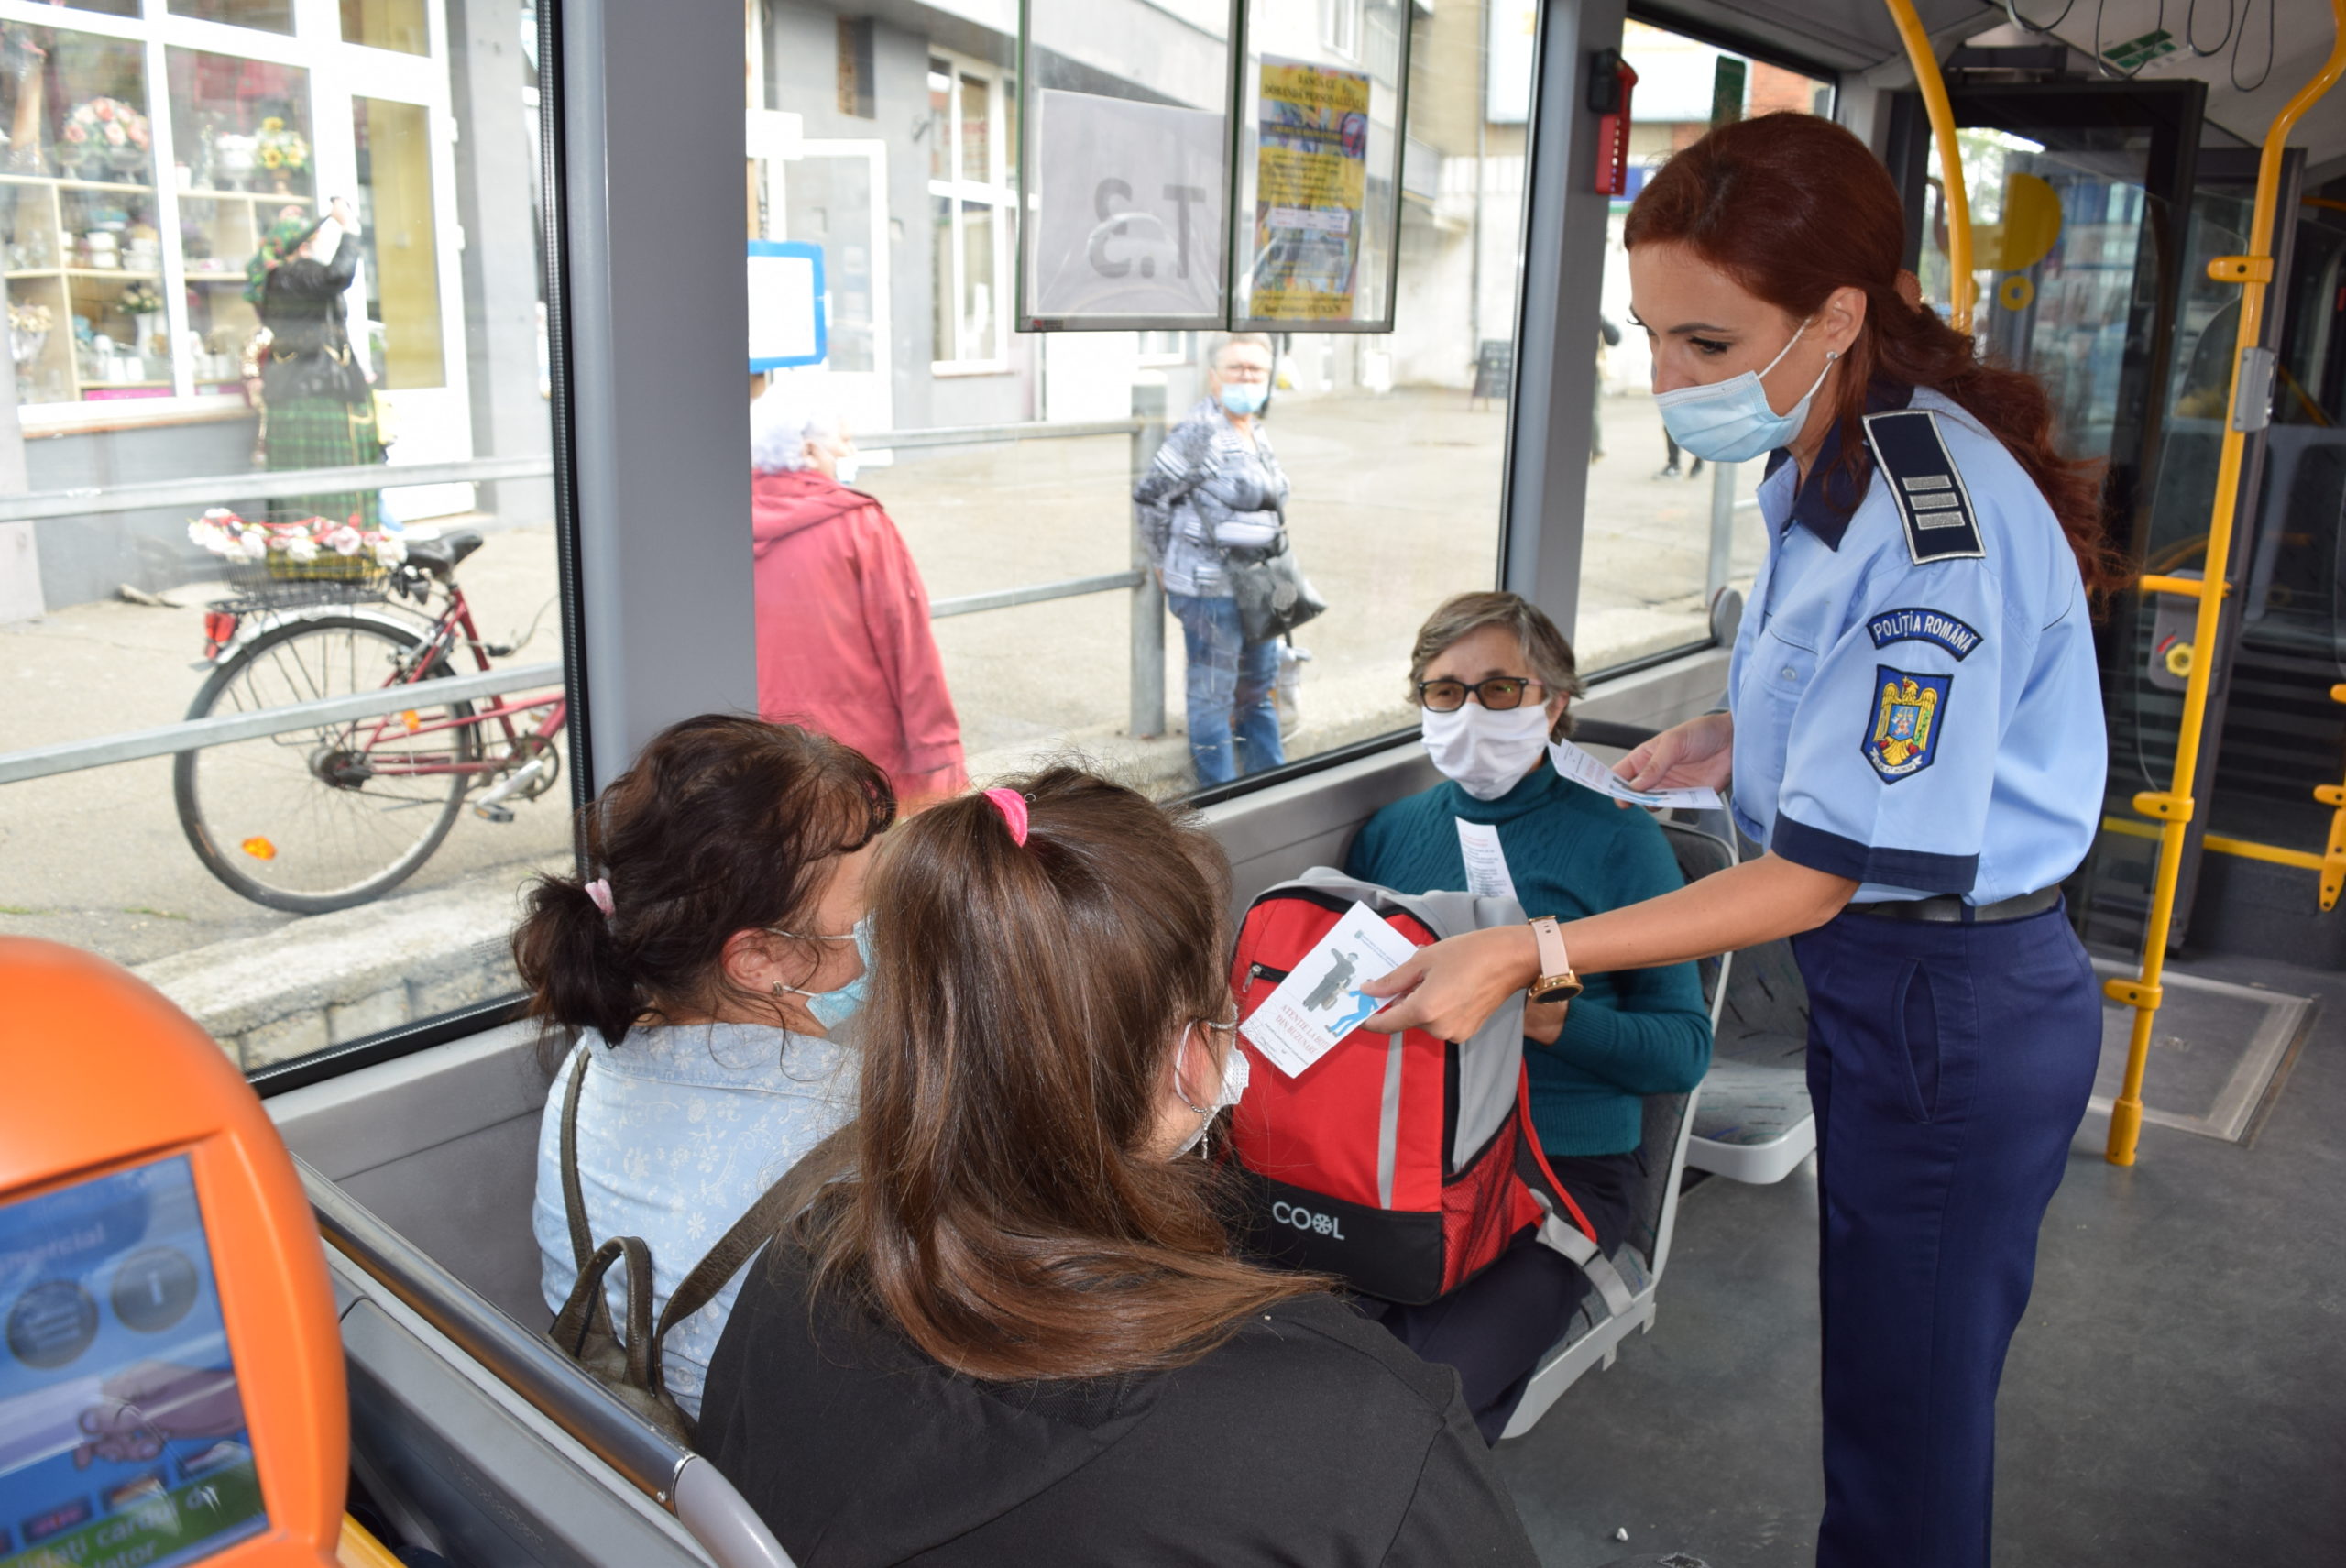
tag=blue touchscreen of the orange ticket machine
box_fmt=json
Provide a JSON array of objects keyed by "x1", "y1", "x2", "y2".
[{"x1": 0, "y1": 1155, "x2": 268, "y2": 1568}]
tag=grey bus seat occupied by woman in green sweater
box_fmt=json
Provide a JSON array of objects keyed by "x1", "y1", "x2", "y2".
[{"x1": 1501, "y1": 812, "x2": 1736, "y2": 1439}]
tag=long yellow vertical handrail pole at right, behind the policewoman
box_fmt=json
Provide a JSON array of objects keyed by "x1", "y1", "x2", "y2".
[{"x1": 2111, "y1": 0, "x2": 2346, "y2": 1164}]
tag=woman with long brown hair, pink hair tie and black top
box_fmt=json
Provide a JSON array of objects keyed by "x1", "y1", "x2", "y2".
[{"x1": 699, "y1": 768, "x2": 1537, "y2": 1568}]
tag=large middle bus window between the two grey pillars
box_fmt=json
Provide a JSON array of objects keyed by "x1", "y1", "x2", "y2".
[{"x1": 749, "y1": 0, "x2": 1534, "y2": 794}]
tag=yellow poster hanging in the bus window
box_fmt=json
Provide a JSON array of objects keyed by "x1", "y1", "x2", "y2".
[{"x1": 1248, "y1": 59, "x2": 1367, "y2": 322}]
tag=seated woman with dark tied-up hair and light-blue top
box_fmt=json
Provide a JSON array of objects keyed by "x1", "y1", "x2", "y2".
[{"x1": 514, "y1": 714, "x2": 896, "y2": 1418}]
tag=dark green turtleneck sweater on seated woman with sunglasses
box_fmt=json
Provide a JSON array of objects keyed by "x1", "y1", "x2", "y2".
[{"x1": 1344, "y1": 762, "x2": 1710, "y2": 1155}]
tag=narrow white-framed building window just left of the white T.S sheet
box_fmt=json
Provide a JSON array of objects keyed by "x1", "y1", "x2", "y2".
[{"x1": 929, "y1": 56, "x2": 1014, "y2": 371}]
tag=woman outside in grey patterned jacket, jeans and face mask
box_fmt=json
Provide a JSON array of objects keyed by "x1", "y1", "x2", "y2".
[{"x1": 1133, "y1": 334, "x2": 1288, "y2": 784}]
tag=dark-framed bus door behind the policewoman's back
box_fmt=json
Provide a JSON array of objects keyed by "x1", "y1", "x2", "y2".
[{"x1": 1891, "y1": 82, "x2": 2289, "y2": 948}]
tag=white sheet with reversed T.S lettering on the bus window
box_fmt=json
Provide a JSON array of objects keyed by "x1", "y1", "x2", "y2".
[{"x1": 1025, "y1": 89, "x2": 1227, "y2": 331}]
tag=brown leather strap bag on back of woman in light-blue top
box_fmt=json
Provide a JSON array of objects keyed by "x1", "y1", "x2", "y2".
[{"x1": 546, "y1": 1045, "x2": 805, "y2": 1448}]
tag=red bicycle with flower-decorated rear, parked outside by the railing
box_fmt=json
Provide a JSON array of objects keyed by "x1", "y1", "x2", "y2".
[{"x1": 171, "y1": 531, "x2": 570, "y2": 916}]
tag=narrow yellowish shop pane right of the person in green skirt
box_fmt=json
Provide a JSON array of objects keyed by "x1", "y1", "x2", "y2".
[{"x1": 352, "y1": 99, "x2": 445, "y2": 389}]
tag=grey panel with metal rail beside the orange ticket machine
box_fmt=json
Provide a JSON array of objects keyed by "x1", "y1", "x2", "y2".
[{"x1": 302, "y1": 1164, "x2": 791, "y2": 1568}]
